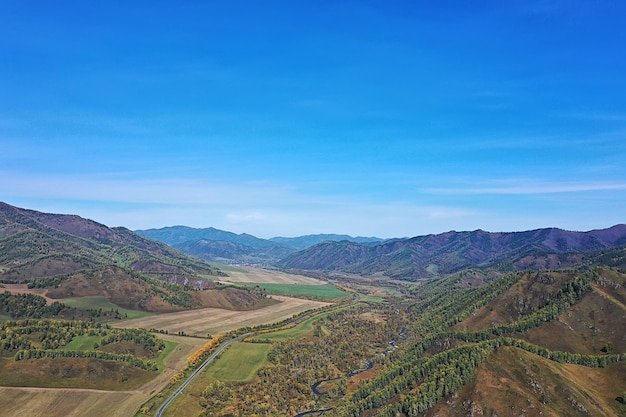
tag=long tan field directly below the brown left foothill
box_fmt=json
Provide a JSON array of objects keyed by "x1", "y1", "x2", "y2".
[{"x1": 115, "y1": 295, "x2": 330, "y2": 337}]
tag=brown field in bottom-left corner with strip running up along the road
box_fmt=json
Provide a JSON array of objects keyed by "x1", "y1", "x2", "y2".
[{"x1": 0, "y1": 335, "x2": 206, "y2": 417}]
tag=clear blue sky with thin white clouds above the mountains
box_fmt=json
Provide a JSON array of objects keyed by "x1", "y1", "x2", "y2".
[{"x1": 0, "y1": 0, "x2": 626, "y2": 238}]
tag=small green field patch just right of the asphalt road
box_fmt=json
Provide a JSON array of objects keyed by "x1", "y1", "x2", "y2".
[{"x1": 206, "y1": 342, "x2": 271, "y2": 382}]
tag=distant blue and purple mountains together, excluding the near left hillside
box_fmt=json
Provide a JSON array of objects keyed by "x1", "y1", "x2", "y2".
[{"x1": 136, "y1": 224, "x2": 626, "y2": 280}]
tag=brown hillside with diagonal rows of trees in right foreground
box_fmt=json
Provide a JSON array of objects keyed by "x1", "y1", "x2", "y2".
[{"x1": 339, "y1": 267, "x2": 626, "y2": 417}]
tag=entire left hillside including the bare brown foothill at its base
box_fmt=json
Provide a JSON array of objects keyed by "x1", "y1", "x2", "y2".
[{"x1": 0, "y1": 202, "x2": 270, "y2": 312}]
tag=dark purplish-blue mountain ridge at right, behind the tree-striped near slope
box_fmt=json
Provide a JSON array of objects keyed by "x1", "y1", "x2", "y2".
[{"x1": 277, "y1": 224, "x2": 626, "y2": 278}]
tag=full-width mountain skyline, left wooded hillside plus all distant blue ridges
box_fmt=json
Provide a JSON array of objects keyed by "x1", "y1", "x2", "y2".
[{"x1": 0, "y1": 203, "x2": 626, "y2": 285}]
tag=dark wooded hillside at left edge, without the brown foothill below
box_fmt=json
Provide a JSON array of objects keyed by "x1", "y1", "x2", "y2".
[{"x1": 0, "y1": 202, "x2": 220, "y2": 282}]
